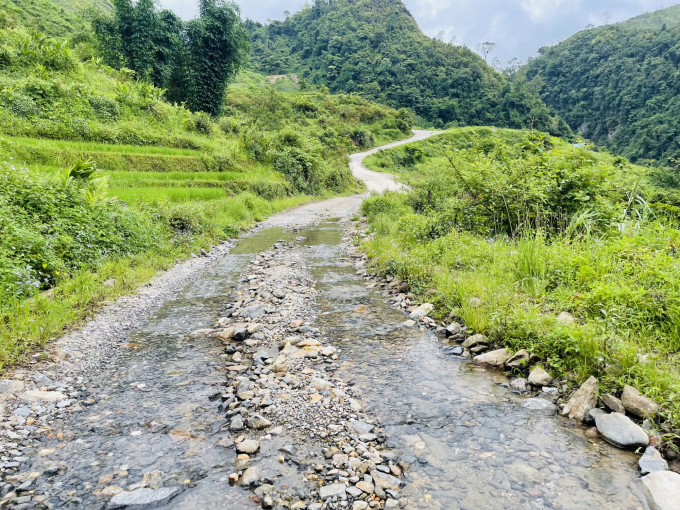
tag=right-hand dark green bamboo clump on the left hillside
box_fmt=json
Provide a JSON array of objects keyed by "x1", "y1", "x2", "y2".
[{"x1": 186, "y1": 0, "x2": 250, "y2": 115}]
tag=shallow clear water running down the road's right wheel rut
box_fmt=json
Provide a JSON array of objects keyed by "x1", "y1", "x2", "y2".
[{"x1": 310, "y1": 222, "x2": 641, "y2": 510}]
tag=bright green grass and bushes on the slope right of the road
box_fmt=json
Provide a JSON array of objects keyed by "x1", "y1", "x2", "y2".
[{"x1": 363, "y1": 128, "x2": 680, "y2": 430}]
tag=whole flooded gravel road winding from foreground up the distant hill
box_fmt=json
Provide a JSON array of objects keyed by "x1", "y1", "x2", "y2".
[{"x1": 0, "y1": 132, "x2": 647, "y2": 510}]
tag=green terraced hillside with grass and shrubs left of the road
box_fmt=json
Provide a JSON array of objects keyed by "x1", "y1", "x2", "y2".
[{"x1": 0, "y1": 0, "x2": 412, "y2": 367}]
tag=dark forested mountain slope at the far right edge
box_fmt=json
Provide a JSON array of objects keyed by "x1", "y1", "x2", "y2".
[{"x1": 518, "y1": 5, "x2": 680, "y2": 163}]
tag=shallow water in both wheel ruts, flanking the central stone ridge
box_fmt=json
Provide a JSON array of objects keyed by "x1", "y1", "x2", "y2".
[{"x1": 27, "y1": 222, "x2": 641, "y2": 510}]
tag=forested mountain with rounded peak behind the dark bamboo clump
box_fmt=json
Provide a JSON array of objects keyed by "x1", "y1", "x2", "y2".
[{"x1": 247, "y1": 0, "x2": 570, "y2": 135}]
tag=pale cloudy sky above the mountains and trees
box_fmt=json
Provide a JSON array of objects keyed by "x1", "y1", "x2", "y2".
[{"x1": 160, "y1": 0, "x2": 680, "y2": 64}]
